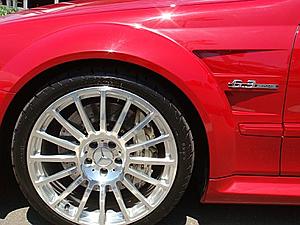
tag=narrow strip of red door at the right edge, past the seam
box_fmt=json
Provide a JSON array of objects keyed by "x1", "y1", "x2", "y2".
[{"x1": 281, "y1": 28, "x2": 300, "y2": 176}]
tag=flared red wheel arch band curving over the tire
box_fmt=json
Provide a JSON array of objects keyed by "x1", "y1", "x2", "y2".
[{"x1": 0, "y1": 23, "x2": 234, "y2": 177}]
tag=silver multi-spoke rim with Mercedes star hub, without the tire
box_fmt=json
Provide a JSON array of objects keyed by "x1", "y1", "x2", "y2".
[{"x1": 27, "y1": 86, "x2": 178, "y2": 225}]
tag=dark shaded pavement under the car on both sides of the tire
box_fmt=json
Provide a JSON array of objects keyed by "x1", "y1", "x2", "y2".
[{"x1": 0, "y1": 171, "x2": 300, "y2": 225}]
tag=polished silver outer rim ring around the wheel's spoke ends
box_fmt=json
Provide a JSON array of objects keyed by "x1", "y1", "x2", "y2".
[{"x1": 27, "y1": 86, "x2": 178, "y2": 225}]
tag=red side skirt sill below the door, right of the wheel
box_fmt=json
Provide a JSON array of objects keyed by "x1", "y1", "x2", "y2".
[{"x1": 201, "y1": 176, "x2": 300, "y2": 205}]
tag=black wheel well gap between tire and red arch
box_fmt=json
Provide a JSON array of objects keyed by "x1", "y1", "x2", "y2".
[{"x1": 0, "y1": 59, "x2": 209, "y2": 194}]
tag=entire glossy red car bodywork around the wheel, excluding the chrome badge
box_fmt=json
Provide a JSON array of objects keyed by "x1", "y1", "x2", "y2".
[{"x1": 0, "y1": 0, "x2": 300, "y2": 204}]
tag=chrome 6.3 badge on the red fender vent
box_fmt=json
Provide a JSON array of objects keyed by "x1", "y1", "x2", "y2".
[{"x1": 228, "y1": 80, "x2": 279, "y2": 90}]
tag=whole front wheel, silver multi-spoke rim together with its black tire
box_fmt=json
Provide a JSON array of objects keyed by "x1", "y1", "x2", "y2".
[{"x1": 12, "y1": 72, "x2": 193, "y2": 225}]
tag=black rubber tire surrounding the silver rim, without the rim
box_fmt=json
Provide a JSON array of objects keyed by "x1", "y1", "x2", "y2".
[{"x1": 12, "y1": 71, "x2": 194, "y2": 225}]
